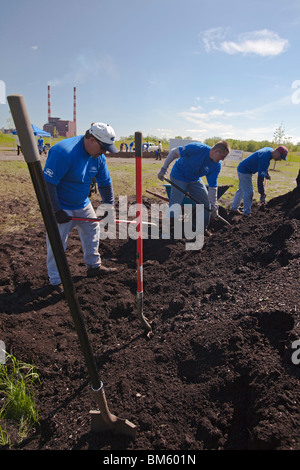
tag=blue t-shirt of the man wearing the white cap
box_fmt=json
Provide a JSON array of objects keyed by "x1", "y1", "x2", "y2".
[{"x1": 44, "y1": 135, "x2": 112, "y2": 210}]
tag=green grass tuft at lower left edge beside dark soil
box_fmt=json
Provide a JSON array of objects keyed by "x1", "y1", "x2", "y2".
[{"x1": 0, "y1": 354, "x2": 40, "y2": 445}]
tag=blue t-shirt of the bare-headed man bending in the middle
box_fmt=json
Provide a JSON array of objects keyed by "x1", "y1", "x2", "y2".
[{"x1": 171, "y1": 142, "x2": 221, "y2": 188}]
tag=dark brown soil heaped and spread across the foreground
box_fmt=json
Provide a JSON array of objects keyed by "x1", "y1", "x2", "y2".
[{"x1": 0, "y1": 188, "x2": 300, "y2": 451}]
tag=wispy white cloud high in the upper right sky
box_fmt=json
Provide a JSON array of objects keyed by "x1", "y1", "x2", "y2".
[{"x1": 200, "y1": 28, "x2": 289, "y2": 57}]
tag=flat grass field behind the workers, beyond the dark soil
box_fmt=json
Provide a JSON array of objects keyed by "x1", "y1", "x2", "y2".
[{"x1": 0, "y1": 157, "x2": 299, "y2": 233}]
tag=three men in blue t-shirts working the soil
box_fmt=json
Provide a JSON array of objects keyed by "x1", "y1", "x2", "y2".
[{"x1": 44, "y1": 122, "x2": 288, "y2": 290}]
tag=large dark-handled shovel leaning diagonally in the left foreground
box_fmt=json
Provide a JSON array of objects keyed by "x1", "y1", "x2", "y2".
[{"x1": 7, "y1": 95, "x2": 136, "y2": 438}]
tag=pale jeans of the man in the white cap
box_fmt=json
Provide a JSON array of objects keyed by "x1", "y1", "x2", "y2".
[{"x1": 46, "y1": 203, "x2": 101, "y2": 285}]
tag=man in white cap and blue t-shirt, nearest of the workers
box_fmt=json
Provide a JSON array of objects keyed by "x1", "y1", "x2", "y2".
[{"x1": 44, "y1": 122, "x2": 118, "y2": 290}]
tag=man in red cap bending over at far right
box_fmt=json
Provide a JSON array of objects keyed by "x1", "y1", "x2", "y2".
[{"x1": 231, "y1": 145, "x2": 288, "y2": 216}]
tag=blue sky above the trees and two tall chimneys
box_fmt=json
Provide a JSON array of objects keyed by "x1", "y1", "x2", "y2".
[{"x1": 0, "y1": 0, "x2": 300, "y2": 143}]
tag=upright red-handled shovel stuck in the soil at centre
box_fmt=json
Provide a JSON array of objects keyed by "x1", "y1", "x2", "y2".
[{"x1": 135, "y1": 132, "x2": 152, "y2": 335}]
